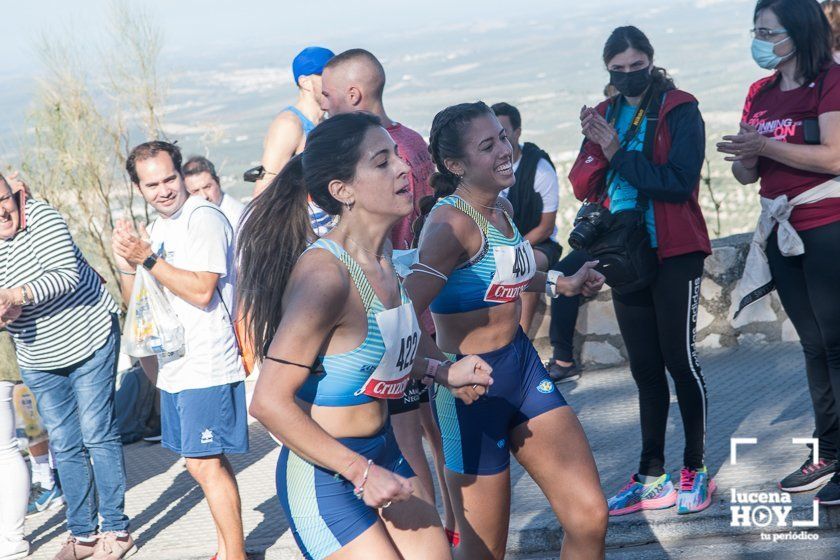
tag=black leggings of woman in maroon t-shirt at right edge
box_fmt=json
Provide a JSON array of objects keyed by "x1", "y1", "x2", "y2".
[{"x1": 767, "y1": 222, "x2": 840, "y2": 459}]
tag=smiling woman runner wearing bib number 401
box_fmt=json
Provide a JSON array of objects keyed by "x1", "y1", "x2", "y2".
[{"x1": 406, "y1": 102, "x2": 607, "y2": 559}]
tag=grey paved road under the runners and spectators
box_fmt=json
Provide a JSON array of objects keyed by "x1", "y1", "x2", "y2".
[{"x1": 27, "y1": 344, "x2": 840, "y2": 560}]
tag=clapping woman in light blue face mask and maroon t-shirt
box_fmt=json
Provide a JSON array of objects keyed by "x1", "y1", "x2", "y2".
[{"x1": 718, "y1": 0, "x2": 840, "y2": 505}]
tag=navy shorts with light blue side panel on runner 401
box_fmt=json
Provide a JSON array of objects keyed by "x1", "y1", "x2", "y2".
[{"x1": 433, "y1": 329, "x2": 566, "y2": 475}]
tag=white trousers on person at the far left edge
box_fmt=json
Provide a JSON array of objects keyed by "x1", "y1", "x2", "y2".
[{"x1": 0, "y1": 381, "x2": 29, "y2": 541}]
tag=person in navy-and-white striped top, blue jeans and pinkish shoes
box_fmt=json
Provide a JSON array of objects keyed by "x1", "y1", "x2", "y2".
[{"x1": 0, "y1": 175, "x2": 136, "y2": 560}]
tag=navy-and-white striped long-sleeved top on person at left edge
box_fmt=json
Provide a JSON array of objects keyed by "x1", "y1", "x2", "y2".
[{"x1": 0, "y1": 200, "x2": 119, "y2": 371}]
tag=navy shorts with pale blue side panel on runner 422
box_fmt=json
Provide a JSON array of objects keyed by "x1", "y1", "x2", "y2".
[{"x1": 277, "y1": 423, "x2": 415, "y2": 560}]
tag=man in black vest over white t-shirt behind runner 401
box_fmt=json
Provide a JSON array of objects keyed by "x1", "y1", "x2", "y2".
[{"x1": 492, "y1": 103, "x2": 562, "y2": 333}]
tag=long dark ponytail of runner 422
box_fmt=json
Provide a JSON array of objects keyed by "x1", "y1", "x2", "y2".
[{"x1": 236, "y1": 155, "x2": 313, "y2": 359}]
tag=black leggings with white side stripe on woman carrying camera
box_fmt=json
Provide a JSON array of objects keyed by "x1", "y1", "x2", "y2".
[{"x1": 613, "y1": 253, "x2": 707, "y2": 476}]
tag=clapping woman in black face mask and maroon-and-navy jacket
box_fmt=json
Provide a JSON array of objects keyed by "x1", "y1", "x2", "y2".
[{"x1": 569, "y1": 26, "x2": 715, "y2": 515}]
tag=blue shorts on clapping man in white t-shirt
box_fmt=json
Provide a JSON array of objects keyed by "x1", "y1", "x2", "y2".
[{"x1": 160, "y1": 381, "x2": 248, "y2": 457}]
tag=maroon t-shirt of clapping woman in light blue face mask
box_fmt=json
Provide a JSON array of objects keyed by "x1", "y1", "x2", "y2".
[{"x1": 741, "y1": 64, "x2": 840, "y2": 231}]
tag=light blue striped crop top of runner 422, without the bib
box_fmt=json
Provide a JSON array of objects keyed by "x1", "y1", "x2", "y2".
[{"x1": 297, "y1": 238, "x2": 411, "y2": 406}]
